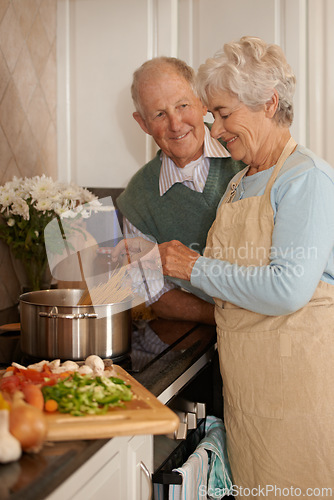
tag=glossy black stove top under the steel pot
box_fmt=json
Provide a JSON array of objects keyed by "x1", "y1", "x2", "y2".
[{"x1": 0, "y1": 311, "x2": 217, "y2": 403}]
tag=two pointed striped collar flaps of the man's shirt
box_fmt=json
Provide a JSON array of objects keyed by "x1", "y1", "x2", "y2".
[{"x1": 159, "y1": 126, "x2": 231, "y2": 196}]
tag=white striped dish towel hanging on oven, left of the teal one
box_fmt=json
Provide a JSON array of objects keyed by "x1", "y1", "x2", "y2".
[{"x1": 168, "y1": 448, "x2": 208, "y2": 500}]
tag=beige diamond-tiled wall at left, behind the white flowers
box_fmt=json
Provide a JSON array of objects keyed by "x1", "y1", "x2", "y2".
[{"x1": 0, "y1": 0, "x2": 57, "y2": 310}]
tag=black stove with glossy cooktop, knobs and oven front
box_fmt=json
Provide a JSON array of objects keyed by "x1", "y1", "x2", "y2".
[{"x1": 0, "y1": 310, "x2": 223, "y2": 500}]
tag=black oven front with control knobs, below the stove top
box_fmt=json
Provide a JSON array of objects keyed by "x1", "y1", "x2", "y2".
[{"x1": 152, "y1": 350, "x2": 223, "y2": 500}]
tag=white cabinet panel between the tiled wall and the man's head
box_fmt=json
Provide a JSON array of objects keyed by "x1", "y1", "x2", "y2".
[{"x1": 58, "y1": 0, "x2": 152, "y2": 187}]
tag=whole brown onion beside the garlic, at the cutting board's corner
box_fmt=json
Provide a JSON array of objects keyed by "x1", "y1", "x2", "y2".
[{"x1": 9, "y1": 391, "x2": 47, "y2": 453}]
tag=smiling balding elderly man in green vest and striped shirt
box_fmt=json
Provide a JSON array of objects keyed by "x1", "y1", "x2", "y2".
[{"x1": 117, "y1": 57, "x2": 244, "y2": 324}]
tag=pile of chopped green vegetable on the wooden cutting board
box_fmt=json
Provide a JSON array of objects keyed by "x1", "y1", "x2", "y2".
[{"x1": 42, "y1": 373, "x2": 132, "y2": 416}]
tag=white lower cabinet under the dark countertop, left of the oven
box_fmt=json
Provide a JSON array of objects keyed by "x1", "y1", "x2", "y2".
[{"x1": 47, "y1": 435, "x2": 153, "y2": 500}]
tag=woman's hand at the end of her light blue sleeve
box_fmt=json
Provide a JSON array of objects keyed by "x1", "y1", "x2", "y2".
[{"x1": 159, "y1": 240, "x2": 200, "y2": 281}]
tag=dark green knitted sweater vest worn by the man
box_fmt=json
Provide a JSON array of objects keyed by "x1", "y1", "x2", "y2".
[{"x1": 117, "y1": 151, "x2": 245, "y2": 254}]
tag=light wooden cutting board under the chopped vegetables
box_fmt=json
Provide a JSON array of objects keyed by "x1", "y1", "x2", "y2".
[{"x1": 46, "y1": 365, "x2": 179, "y2": 441}]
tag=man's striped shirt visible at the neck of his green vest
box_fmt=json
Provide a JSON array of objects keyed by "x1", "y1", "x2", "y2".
[{"x1": 159, "y1": 123, "x2": 231, "y2": 196}]
